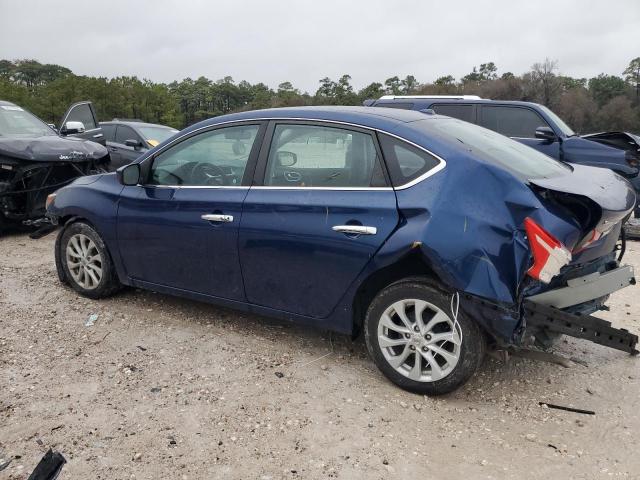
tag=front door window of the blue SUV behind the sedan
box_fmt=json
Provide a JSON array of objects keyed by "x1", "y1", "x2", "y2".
[{"x1": 480, "y1": 105, "x2": 549, "y2": 138}]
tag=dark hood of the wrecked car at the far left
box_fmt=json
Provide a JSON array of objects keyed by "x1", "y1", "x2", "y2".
[{"x1": 0, "y1": 135, "x2": 107, "y2": 162}]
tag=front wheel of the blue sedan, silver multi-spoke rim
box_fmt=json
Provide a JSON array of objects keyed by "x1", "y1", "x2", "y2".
[{"x1": 56, "y1": 222, "x2": 120, "y2": 298}]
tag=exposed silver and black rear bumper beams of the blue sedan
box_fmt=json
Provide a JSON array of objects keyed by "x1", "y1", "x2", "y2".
[{"x1": 523, "y1": 265, "x2": 639, "y2": 355}]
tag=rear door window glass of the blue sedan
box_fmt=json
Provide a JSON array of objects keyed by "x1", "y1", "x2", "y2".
[{"x1": 264, "y1": 124, "x2": 386, "y2": 188}]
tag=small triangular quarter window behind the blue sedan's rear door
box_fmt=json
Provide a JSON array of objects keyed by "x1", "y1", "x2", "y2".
[{"x1": 380, "y1": 134, "x2": 440, "y2": 187}]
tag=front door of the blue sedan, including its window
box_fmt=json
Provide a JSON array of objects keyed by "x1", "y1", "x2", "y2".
[{"x1": 117, "y1": 124, "x2": 264, "y2": 300}]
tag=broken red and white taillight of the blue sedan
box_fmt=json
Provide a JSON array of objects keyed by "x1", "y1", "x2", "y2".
[{"x1": 524, "y1": 217, "x2": 571, "y2": 283}]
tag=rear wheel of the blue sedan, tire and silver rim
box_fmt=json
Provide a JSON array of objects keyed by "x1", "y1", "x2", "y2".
[{"x1": 364, "y1": 281, "x2": 486, "y2": 395}]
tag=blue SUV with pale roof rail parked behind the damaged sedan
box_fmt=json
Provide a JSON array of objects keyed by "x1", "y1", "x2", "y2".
[{"x1": 365, "y1": 95, "x2": 640, "y2": 216}]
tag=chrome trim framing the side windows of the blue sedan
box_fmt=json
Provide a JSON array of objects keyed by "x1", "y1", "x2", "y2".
[{"x1": 144, "y1": 117, "x2": 447, "y2": 191}]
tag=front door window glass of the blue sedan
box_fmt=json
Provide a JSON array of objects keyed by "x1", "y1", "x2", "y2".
[{"x1": 150, "y1": 125, "x2": 259, "y2": 186}]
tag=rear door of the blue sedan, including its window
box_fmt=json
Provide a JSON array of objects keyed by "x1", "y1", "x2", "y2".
[{"x1": 239, "y1": 121, "x2": 398, "y2": 318}]
